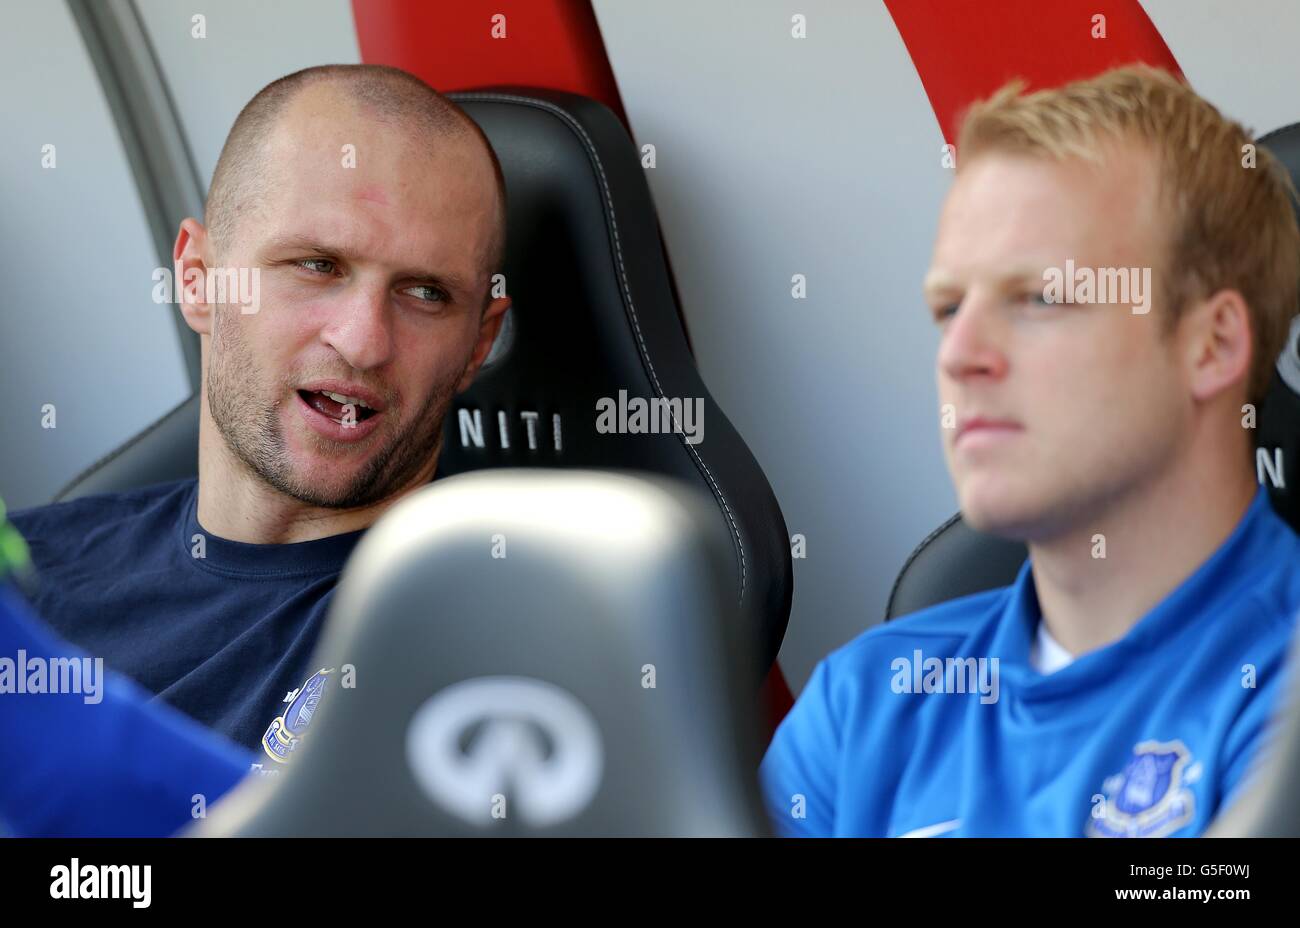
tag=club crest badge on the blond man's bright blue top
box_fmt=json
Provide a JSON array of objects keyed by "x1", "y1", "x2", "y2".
[{"x1": 1087, "y1": 741, "x2": 1200, "y2": 838}]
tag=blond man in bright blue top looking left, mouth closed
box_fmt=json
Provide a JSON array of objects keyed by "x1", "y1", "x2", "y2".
[{"x1": 762, "y1": 66, "x2": 1300, "y2": 837}]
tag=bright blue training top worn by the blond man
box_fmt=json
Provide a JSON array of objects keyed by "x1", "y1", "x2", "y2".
[{"x1": 761, "y1": 487, "x2": 1300, "y2": 837}]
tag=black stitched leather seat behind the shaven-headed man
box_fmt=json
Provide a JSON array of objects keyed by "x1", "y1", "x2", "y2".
[{"x1": 57, "y1": 88, "x2": 793, "y2": 667}]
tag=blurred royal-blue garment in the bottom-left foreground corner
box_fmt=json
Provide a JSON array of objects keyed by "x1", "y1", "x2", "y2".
[{"x1": 0, "y1": 578, "x2": 252, "y2": 837}]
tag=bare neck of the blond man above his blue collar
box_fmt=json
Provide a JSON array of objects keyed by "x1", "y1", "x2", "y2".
[{"x1": 1028, "y1": 454, "x2": 1257, "y2": 655}]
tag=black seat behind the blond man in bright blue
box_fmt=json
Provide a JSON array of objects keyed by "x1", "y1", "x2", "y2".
[{"x1": 885, "y1": 123, "x2": 1300, "y2": 621}]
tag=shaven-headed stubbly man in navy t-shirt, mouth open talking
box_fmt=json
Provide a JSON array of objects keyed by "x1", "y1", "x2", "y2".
[{"x1": 12, "y1": 65, "x2": 510, "y2": 769}]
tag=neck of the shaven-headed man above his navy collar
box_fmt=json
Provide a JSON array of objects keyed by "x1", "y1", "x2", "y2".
[{"x1": 198, "y1": 405, "x2": 437, "y2": 545}]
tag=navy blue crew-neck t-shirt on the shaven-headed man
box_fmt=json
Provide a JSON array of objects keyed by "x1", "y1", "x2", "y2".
[{"x1": 9, "y1": 480, "x2": 363, "y2": 753}]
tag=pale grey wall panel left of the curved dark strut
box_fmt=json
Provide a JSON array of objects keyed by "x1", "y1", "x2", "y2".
[{"x1": 0, "y1": 0, "x2": 189, "y2": 508}]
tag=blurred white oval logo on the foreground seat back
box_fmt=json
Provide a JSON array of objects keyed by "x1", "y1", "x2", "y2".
[{"x1": 407, "y1": 677, "x2": 605, "y2": 827}]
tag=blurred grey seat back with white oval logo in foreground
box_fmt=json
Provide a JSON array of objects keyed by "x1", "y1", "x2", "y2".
[{"x1": 199, "y1": 469, "x2": 764, "y2": 837}]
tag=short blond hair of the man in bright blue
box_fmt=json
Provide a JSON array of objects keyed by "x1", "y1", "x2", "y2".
[{"x1": 957, "y1": 65, "x2": 1300, "y2": 402}]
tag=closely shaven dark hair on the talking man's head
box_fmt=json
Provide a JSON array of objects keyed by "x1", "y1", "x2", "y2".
[{"x1": 204, "y1": 65, "x2": 506, "y2": 274}]
